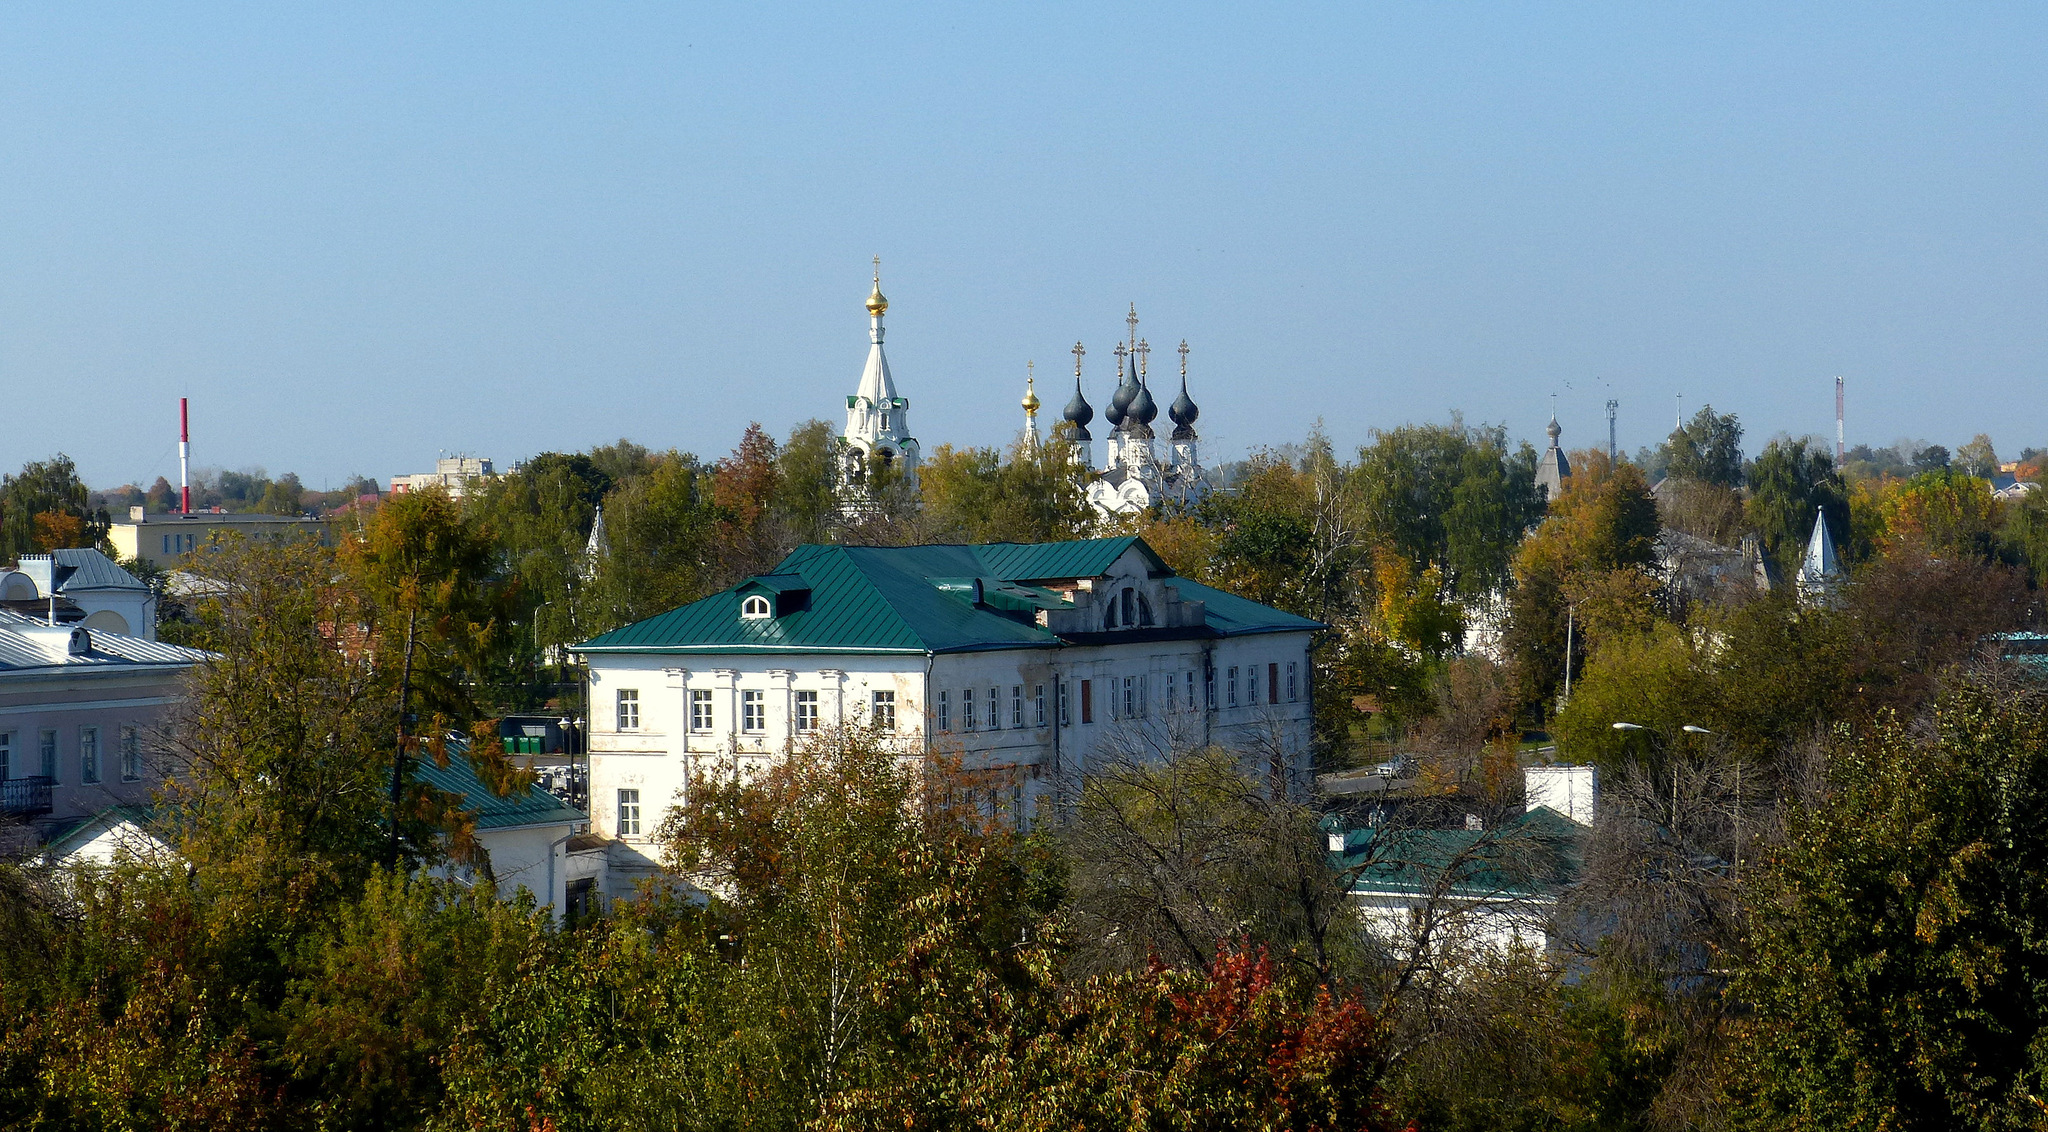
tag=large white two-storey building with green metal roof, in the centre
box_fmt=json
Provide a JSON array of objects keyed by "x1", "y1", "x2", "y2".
[{"x1": 580, "y1": 538, "x2": 1321, "y2": 895}]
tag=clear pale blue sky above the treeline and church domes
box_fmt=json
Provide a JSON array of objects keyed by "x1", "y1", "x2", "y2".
[{"x1": 0, "y1": 4, "x2": 2048, "y2": 487}]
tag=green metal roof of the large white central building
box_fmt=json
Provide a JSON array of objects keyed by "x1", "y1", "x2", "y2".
[{"x1": 580, "y1": 536, "x2": 1325, "y2": 655}]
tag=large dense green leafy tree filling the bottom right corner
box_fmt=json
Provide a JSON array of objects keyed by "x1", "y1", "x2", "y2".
[{"x1": 1731, "y1": 688, "x2": 2048, "y2": 1130}]
